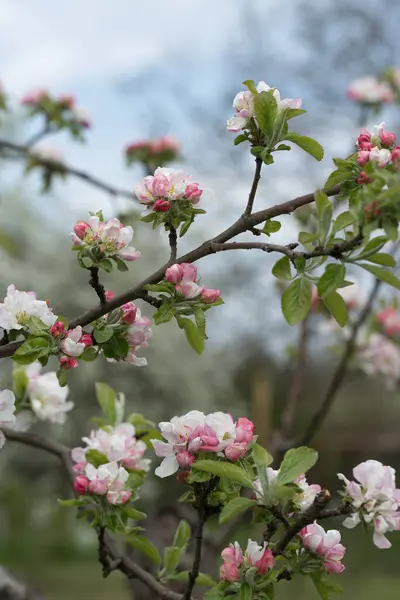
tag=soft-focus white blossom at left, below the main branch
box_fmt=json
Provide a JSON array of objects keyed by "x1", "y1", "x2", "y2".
[{"x1": 25, "y1": 363, "x2": 74, "y2": 424}]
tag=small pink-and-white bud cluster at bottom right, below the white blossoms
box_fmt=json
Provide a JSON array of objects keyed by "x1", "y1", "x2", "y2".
[{"x1": 299, "y1": 523, "x2": 346, "y2": 573}]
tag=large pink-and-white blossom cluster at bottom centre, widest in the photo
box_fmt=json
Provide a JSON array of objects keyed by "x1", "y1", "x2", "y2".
[{"x1": 151, "y1": 410, "x2": 254, "y2": 477}]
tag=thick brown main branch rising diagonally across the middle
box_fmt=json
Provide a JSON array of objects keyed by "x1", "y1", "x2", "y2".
[{"x1": 0, "y1": 185, "x2": 340, "y2": 358}]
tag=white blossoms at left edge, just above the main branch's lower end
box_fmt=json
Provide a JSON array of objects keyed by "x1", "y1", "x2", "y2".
[{"x1": 0, "y1": 285, "x2": 57, "y2": 331}]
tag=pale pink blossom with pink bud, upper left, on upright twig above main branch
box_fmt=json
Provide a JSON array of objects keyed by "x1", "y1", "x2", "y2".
[{"x1": 71, "y1": 215, "x2": 140, "y2": 261}]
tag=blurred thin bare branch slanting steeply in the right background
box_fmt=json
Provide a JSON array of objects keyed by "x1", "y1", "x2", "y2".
[{"x1": 298, "y1": 279, "x2": 382, "y2": 446}]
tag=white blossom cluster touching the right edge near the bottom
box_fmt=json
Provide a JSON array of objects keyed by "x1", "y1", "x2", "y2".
[{"x1": 338, "y1": 460, "x2": 400, "y2": 549}]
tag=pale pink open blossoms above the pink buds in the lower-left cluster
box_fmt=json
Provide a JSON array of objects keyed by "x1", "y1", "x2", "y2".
[{"x1": 71, "y1": 423, "x2": 150, "y2": 475}]
